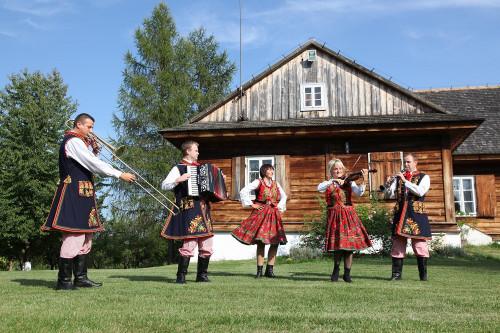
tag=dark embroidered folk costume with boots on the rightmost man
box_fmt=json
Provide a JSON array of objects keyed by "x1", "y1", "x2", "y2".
[{"x1": 386, "y1": 171, "x2": 432, "y2": 281}]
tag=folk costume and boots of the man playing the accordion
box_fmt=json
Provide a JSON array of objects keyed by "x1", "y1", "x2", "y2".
[{"x1": 161, "y1": 160, "x2": 213, "y2": 283}]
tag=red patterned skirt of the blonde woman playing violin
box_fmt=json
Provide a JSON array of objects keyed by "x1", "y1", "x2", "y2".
[{"x1": 325, "y1": 205, "x2": 372, "y2": 251}]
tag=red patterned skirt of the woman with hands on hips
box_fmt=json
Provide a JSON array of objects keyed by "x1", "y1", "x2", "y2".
[{"x1": 231, "y1": 205, "x2": 287, "y2": 245}]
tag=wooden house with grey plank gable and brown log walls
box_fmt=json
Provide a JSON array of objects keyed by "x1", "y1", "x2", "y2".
[{"x1": 161, "y1": 40, "x2": 488, "y2": 258}]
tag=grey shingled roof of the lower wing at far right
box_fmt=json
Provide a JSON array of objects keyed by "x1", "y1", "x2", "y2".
[{"x1": 416, "y1": 86, "x2": 500, "y2": 155}]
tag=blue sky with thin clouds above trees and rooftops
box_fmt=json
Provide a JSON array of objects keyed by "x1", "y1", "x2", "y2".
[{"x1": 0, "y1": 0, "x2": 500, "y2": 136}]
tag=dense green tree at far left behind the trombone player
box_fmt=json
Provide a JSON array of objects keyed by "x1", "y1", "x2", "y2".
[{"x1": 0, "y1": 70, "x2": 77, "y2": 268}]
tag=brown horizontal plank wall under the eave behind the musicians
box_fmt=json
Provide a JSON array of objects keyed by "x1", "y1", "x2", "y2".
[{"x1": 202, "y1": 150, "x2": 450, "y2": 232}]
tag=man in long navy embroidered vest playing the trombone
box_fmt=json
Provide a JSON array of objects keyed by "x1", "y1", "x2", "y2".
[{"x1": 41, "y1": 113, "x2": 136, "y2": 290}]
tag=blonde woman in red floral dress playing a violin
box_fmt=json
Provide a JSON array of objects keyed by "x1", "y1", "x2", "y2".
[{"x1": 318, "y1": 159, "x2": 372, "y2": 282}]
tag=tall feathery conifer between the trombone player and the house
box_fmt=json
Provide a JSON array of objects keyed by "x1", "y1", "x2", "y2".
[{"x1": 102, "y1": 3, "x2": 235, "y2": 266}]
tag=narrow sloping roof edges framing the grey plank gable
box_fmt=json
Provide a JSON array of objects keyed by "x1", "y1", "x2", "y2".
[{"x1": 189, "y1": 39, "x2": 447, "y2": 123}]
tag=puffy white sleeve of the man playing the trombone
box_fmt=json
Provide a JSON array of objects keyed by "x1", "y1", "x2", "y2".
[{"x1": 65, "y1": 138, "x2": 122, "y2": 178}]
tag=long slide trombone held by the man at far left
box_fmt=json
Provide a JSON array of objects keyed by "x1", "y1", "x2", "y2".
[{"x1": 66, "y1": 119, "x2": 180, "y2": 215}]
